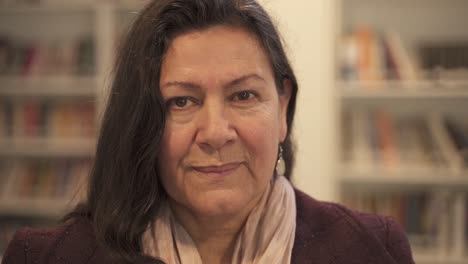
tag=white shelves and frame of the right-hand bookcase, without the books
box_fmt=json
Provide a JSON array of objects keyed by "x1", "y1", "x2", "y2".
[{"x1": 335, "y1": 0, "x2": 468, "y2": 264}]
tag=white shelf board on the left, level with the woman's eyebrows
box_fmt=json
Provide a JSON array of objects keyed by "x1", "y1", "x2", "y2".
[{"x1": 0, "y1": 76, "x2": 97, "y2": 97}]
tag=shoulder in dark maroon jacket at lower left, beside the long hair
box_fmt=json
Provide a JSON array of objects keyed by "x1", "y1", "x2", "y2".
[{"x1": 2, "y1": 219, "x2": 109, "y2": 264}]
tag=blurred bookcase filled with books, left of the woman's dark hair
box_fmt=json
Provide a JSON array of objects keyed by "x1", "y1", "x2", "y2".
[{"x1": 0, "y1": 0, "x2": 116, "y2": 256}]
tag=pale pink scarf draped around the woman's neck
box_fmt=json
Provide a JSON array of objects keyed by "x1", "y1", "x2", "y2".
[{"x1": 143, "y1": 176, "x2": 296, "y2": 264}]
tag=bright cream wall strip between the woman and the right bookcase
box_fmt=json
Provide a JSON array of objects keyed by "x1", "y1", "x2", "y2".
[{"x1": 260, "y1": 0, "x2": 338, "y2": 200}]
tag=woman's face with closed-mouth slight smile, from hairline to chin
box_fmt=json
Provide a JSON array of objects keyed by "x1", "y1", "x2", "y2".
[{"x1": 158, "y1": 26, "x2": 289, "y2": 217}]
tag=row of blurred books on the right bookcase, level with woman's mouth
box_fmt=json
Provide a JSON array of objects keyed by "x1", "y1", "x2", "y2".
[{"x1": 342, "y1": 108, "x2": 468, "y2": 174}]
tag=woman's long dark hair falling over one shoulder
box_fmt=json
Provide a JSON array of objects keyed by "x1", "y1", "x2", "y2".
[{"x1": 69, "y1": 0, "x2": 297, "y2": 263}]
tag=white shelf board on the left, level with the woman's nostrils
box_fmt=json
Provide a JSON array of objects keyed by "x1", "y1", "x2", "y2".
[{"x1": 0, "y1": 139, "x2": 95, "y2": 158}]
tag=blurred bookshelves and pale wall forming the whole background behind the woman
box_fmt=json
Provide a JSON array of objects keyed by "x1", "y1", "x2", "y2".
[{"x1": 0, "y1": 0, "x2": 468, "y2": 264}]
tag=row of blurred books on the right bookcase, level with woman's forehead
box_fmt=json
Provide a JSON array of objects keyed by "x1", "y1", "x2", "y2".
[{"x1": 341, "y1": 26, "x2": 468, "y2": 83}]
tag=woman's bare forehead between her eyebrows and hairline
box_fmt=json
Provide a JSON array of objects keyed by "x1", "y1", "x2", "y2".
[{"x1": 160, "y1": 26, "x2": 273, "y2": 83}]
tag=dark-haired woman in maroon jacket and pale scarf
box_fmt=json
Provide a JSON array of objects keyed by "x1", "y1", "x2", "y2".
[{"x1": 4, "y1": 0, "x2": 413, "y2": 264}]
